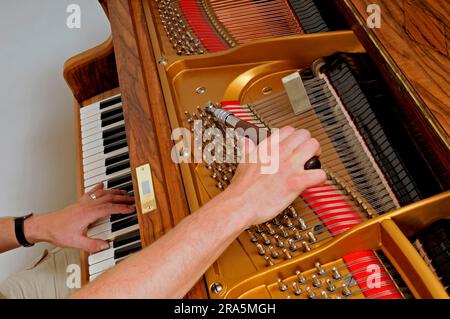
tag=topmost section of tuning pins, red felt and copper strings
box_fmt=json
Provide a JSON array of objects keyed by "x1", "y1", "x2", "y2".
[{"x1": 157, "y1": 0, "x2": 348, "y2": 55}]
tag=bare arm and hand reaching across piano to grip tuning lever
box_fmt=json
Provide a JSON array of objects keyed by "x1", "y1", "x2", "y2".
[{"x1": 73, "y1": 128, "x2": 325, "y2": 298}]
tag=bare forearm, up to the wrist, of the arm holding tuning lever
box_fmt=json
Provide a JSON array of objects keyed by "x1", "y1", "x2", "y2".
[{"x1": 73, "y1": 192, "x2": 245, "y2": 298}]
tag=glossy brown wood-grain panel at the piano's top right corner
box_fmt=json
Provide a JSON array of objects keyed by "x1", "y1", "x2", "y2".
[{"x1": 335, "y1": 0, "x2": 450, "y2": 189}]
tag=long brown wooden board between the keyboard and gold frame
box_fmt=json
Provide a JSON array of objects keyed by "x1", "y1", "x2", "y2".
[{"x1": 106, "y1": 0, "x2": 206, "y2": 298}]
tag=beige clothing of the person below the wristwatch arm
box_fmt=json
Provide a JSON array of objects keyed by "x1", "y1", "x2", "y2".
[{"x1": 0, "y1": 248, "x2": 80, "y2": 299}]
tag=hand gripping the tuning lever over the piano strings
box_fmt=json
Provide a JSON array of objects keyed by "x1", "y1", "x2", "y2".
[{"x1": 224, "y1": 127, "x2": 326, "y2": 227}]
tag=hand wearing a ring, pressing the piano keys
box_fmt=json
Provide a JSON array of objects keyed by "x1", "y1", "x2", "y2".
[{"x1": 25, "y1": 183, "x2": 135, "y2": 252}]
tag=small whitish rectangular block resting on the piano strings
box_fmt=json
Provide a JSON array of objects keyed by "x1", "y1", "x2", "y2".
[{"x1": 282, "y1": 72, "x2": 311, "y2": 115}]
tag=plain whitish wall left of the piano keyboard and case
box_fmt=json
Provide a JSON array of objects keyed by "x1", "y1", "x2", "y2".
[{"x1": 0, "y1": 0, "x2": 110, "y2": 282}]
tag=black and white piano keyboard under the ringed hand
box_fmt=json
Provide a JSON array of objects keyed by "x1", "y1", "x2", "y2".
[{"x1": 80, "y1": 95, "x2": 142, "y2": 281}]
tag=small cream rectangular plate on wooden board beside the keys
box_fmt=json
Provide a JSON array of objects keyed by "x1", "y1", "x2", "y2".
[{"x1": 136, "y1": 164, "x2": 157, "y2": 214}]
